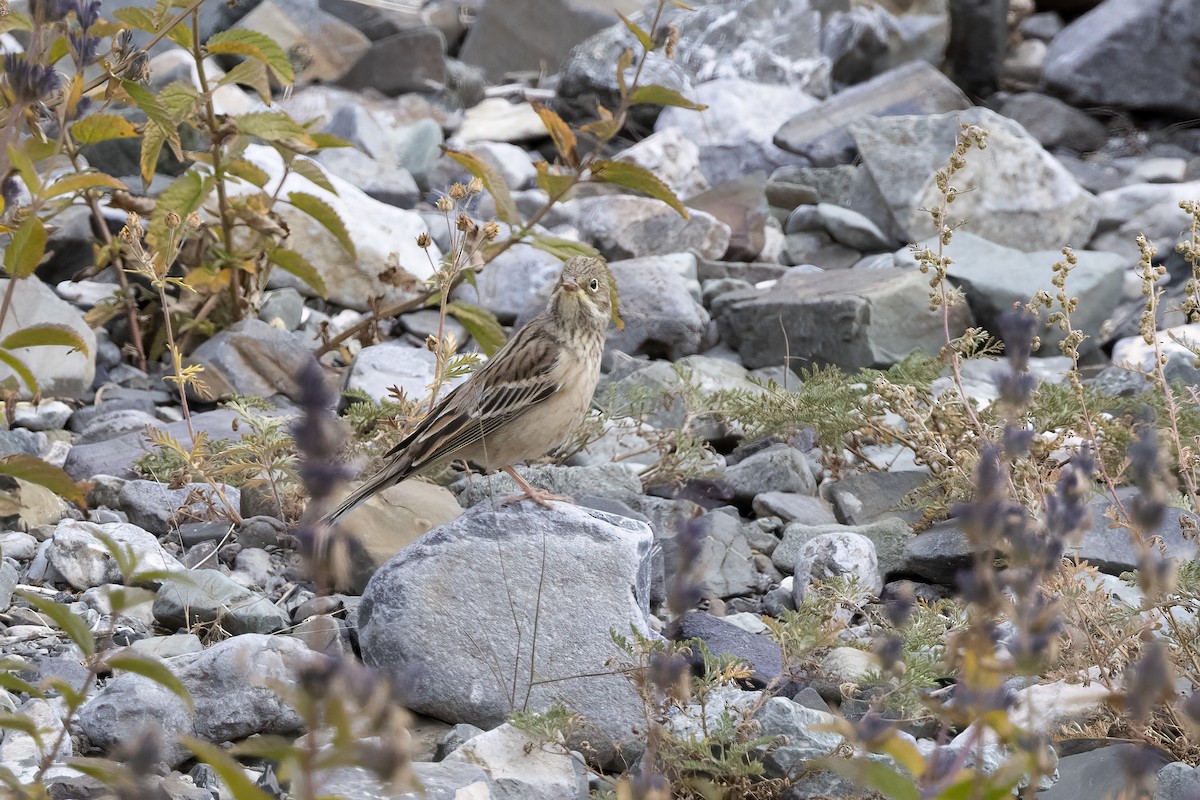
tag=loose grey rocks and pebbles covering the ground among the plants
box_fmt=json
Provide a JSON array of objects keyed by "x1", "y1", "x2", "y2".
[{"x1": 0, "y1": 0, "x2": 1200, "y2": 800}]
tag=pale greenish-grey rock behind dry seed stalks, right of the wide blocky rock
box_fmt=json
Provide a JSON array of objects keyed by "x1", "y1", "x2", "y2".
[{"x1": 895, "y1": 232, "x2": 1133, "y2": 353}]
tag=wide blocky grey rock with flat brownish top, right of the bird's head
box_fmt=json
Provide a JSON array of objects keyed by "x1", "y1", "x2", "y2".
[{"x1": 713, "y1": 270, "x2": 971, "y2": 372}]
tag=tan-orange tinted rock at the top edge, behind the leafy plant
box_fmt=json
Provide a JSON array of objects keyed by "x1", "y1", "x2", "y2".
[{"x1": 238, "y1": 0, "x2": 371, "y2": 84}]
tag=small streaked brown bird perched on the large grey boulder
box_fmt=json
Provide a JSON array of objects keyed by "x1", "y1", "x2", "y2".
[{"x1": 325, "y1": 255, "x2": 613, "y2": 524}]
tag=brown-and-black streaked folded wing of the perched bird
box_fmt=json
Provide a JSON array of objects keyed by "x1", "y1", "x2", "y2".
[{"x1": 385, "y1": 320, "x2": 563, "y2": 471}]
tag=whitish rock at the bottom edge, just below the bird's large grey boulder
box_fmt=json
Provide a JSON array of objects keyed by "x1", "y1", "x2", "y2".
[{"x1": 443, "y1": 723, "x2": 588, "y2": 800}]
